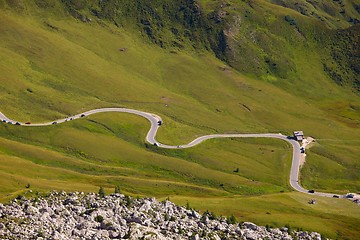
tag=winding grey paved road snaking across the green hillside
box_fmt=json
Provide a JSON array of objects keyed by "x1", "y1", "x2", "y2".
[{"x1": 0, "y1": 108, "x2": 344, "y2": 198}]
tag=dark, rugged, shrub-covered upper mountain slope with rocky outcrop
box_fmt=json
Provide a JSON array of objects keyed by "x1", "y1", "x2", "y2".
[{"x1": 54, "y1": 0, "x2": 360, "y2": 91}]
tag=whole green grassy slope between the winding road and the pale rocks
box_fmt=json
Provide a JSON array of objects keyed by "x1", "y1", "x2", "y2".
[{"x1": 0, "y1": 114, "x2": 360, "y2": 239}]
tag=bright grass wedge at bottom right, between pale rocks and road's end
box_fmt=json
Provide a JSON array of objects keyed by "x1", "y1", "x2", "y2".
[{"x1": 170, "y1": 193, "x2": 359, "y2": 239}]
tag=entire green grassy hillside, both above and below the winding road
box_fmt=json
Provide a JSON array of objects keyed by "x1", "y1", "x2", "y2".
[{"x1": 0, "y1": 0, "x2": 360, "y2": 238}]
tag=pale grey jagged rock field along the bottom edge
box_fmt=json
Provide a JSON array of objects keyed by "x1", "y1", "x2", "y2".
[{"x1": 0, "y1": 191, "x2": 321, "y2": 240}]
